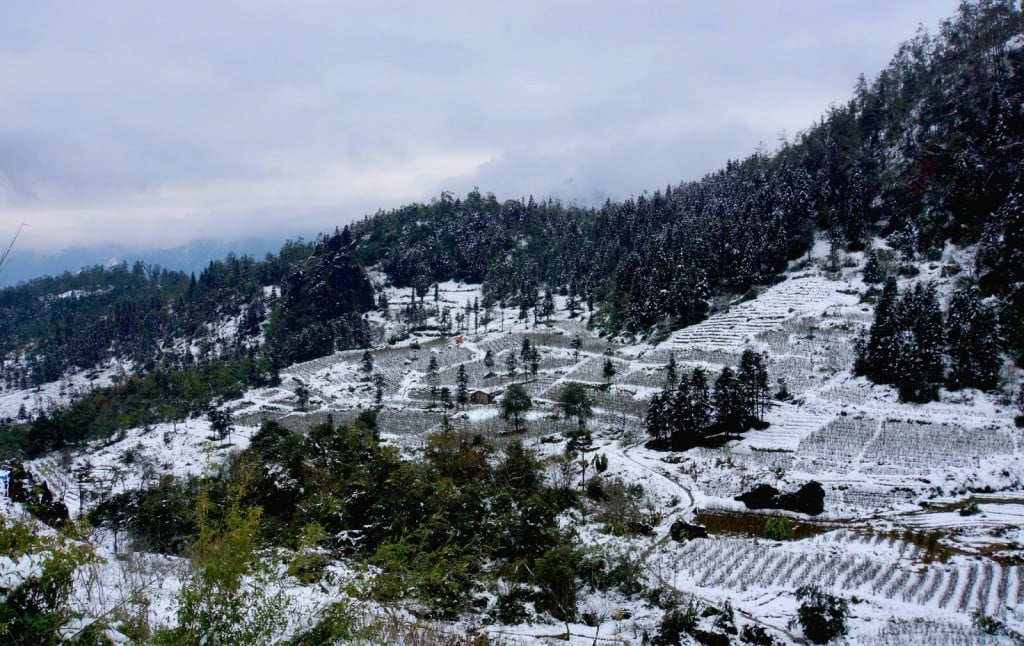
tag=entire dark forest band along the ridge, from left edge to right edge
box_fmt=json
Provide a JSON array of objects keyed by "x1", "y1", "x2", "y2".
[{"x1": 0, "y1": 0, "x2": 1024, "y2": 454}]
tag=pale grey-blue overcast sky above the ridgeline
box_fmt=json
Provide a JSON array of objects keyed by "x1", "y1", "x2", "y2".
[{"x1": 0, "y1": 0, "x2": 957, "y2": 251}]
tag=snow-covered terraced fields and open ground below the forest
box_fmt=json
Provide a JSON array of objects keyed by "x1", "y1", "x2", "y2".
[{"x1": 0, "y1": 241, "x2": 1024, "y2": 644}]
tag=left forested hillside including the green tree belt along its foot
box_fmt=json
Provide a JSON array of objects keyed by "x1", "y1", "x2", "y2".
[{"x1": 0, "y1": 229, "x2": 375, "y2": 456}]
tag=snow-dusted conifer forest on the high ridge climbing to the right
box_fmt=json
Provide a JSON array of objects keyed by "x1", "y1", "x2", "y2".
[{"x1": 353, "y1": 1, "x2": 1024, "y2": 352}]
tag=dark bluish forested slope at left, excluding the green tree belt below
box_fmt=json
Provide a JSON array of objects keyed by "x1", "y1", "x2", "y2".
[{"x1": 0, "y1": 229, "x2": 374, "y2": 388}]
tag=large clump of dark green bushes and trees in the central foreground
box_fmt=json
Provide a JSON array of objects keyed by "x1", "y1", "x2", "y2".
[{"x1": 93, "y1": 420, "x2": 651, "y2": 622}]
